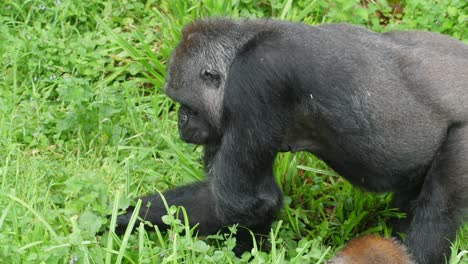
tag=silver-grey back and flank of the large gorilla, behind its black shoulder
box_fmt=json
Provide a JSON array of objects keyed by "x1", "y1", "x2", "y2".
[{"x1": 272, "y1": 21, "x2": 468, "y2": 191}]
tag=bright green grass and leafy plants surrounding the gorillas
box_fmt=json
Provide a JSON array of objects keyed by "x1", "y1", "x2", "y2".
[{"x1": 0, "y1": 0, "x2": 468, "y2": 263}]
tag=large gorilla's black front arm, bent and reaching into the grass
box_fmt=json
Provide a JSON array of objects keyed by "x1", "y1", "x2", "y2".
[{"x1": 117, "y1": 35, "x2": 292, "y2": 241}]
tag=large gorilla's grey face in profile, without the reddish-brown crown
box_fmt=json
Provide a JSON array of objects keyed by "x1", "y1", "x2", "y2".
[{"x1": 164, "y1": 36, "x2": 230, "y2": 145}]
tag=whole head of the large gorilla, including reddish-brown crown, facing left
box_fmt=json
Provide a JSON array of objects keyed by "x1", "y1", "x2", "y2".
[{"x1": 164, "y1": 20, "x2": 243, "y2": 145}]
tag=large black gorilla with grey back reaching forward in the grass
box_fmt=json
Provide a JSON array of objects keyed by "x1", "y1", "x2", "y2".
[{"x1": 117, "y1": 19, "x2": 468, "y2": 263}]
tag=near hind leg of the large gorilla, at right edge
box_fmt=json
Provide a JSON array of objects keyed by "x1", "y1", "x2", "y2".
[{"x1": 406, "y1": 123, "x2": 468, "y2": 264}]
